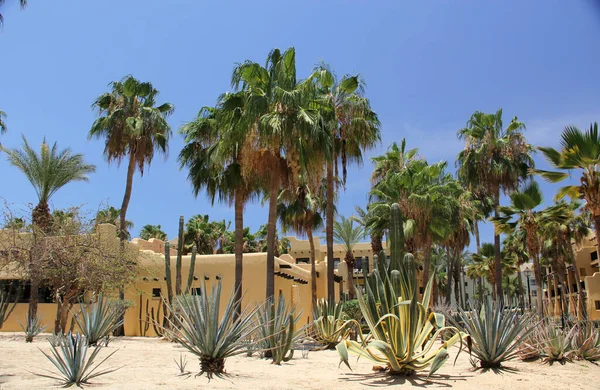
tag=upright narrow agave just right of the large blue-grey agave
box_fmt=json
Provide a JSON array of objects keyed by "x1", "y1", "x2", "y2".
[{"x1": 256, "y1": 294, "x2": 303, "y2": 365}]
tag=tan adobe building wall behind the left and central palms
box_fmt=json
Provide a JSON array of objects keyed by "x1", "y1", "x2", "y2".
[{"x1": 0, "y1": 225, "x2": 340, "y2": 336}]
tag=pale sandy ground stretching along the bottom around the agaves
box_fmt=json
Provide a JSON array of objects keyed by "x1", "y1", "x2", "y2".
[{"x1": 0, "y1": 334, "x2": 600, "y2": 390}]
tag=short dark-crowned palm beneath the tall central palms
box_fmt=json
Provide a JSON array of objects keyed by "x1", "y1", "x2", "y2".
[{"x1": 277, "y1": 184, "x2": 325, "y2": 305}]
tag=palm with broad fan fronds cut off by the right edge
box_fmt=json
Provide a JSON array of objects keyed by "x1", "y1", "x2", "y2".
[{"x1": 535, "y1": 122, "x2": 600, "y2": 250}]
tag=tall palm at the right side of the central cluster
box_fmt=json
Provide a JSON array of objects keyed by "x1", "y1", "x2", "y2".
[{"x1": 309, "y1": 63, "x2": 381, "y2": 301}]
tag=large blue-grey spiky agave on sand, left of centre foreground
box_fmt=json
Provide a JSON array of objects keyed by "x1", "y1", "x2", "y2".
[{"x1": 169, "y1": 281, "x2": 258, "y2": 380}]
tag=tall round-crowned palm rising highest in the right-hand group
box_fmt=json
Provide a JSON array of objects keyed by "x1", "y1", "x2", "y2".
[{"x1": 456, "y1": 109, "x2": 534, "y2": 300}]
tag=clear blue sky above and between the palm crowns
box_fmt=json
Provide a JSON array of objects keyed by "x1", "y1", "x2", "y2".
[{"x1": 0, "y1": 0, "x2": 600, "y2": 250}]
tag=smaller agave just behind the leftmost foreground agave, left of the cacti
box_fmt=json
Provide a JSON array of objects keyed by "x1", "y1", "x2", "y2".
[{"x1": 75, "y1": 294, "x2": 123, "y2": 345}]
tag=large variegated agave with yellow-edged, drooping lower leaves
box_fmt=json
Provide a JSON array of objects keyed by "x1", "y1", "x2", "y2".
[{"x1": 336, "y1": 254, "x2": 466, "y2": 375}]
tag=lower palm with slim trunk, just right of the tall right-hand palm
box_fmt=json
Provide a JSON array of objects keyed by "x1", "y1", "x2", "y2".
[{"x1": 492, "y1": 180, "x2": 544, "y2": 316}]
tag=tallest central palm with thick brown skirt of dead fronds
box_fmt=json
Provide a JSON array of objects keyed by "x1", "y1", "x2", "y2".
[{"x1": 232, "y1": 48, "x2": 328, "y2": 299}]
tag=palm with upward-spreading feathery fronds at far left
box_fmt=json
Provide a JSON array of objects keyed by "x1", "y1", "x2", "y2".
[{"x1": 2, "y1": 136, "x2": 96, "y2": 318}]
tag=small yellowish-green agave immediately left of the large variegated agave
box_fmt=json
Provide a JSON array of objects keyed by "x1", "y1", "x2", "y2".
[{"x1": 311, "y1": 299, "x2": 352, "y2": 349}]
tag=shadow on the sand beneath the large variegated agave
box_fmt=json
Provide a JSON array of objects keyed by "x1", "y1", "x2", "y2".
[{"x1": 341, "y1": 372, "x2": 472, "y2": 387}]
